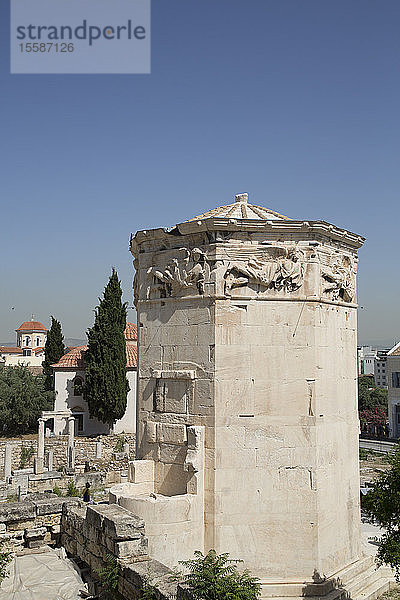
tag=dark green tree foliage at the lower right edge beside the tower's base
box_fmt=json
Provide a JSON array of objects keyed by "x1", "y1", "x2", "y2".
[{"x1": 362, "y1": 446, "x2": 400, "y2": 581}]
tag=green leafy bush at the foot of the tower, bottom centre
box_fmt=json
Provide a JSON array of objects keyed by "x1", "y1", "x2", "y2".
[{"x1": 177, "y1": 550, "x2": 261, "y2": 600}]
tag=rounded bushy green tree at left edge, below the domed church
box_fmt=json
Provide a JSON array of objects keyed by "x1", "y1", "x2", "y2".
[{"x1": 0, "y1": 366, "x2": 54, "y2": 435}]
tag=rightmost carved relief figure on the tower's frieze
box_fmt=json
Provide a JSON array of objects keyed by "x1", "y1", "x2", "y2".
[{"x1": 321, "y1": 254, "x2": 357, "y2": 302}]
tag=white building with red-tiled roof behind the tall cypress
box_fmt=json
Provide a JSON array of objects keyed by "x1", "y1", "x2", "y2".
[{"x1": 48, "y1": 323, "x2": 137, "y2": 435}]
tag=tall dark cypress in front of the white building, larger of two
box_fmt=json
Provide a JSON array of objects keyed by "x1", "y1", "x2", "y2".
[{"x1": 83, "y1": 269, "x2": 129, "y2": 426}]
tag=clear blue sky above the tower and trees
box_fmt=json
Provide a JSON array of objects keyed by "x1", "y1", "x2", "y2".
[{"x1": 0, "y1": 0, "x2": 400, "y2": 344}]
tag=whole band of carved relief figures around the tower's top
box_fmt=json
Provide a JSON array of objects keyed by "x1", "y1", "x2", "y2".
[{"x1": 134, "y1": 242, "x2": 357, "y2": 302}]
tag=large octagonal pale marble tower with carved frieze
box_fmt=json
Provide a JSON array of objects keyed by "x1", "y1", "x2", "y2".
[{"x1": 126, "y1": 194, "x2": 388, "y2": 596}]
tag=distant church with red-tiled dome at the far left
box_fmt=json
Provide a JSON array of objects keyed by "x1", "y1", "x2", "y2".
[{"x1": 0, "y1": 318, "x2": 47, "y2": 367}]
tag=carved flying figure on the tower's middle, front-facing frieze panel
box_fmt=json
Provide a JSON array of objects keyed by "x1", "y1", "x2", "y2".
[{"x1": 224, "y1": 246, "x2": 305, "y2": 296}]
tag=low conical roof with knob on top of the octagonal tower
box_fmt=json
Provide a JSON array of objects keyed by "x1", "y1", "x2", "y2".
[{"x1": 185, "y1": 194, "x2": 291, "y2": 223}]
